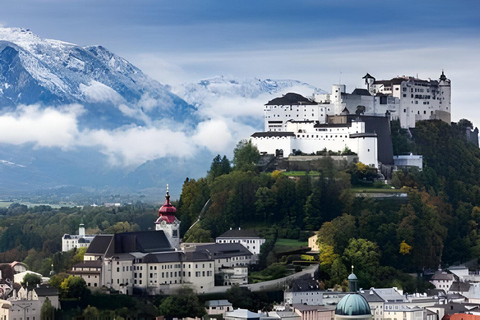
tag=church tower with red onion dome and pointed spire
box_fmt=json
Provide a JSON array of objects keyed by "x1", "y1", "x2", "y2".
[{"x1": 155, "y1": 184, "x2": 180, "y2": 249}]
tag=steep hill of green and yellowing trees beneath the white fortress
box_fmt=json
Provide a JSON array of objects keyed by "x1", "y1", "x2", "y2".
[{"x1": 179, "y1": 121, "x2": 480, "y2": 285}]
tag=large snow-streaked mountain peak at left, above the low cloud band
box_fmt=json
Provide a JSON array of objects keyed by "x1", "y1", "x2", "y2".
[{"x1": 0, "y1": 28, "x2": 195, "y2": 127}]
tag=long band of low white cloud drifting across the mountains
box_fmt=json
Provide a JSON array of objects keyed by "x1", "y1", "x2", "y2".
[{"x1": 0, "y1": 105, "x2": 254, "y2": 168}]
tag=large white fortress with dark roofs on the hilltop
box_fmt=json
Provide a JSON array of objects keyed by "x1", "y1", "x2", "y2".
[{"x1": 251, "y1": 71, "x2": 451, "y2": 168}]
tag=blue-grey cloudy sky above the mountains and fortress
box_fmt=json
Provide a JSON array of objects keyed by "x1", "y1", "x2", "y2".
[{"x1": 0, "y1": 0, "x2": 480, "y2": 125}]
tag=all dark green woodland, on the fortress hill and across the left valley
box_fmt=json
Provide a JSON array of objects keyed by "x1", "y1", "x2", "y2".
[{"x1": 0, "y1": 120, "x2": 480, "y2": 291}]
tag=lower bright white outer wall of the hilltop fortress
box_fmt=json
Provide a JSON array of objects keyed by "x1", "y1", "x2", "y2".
[{"x1": 251, "y1": 121, "x2": 378, "y2": 168}]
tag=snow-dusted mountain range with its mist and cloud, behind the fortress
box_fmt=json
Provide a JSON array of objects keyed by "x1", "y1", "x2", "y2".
[{"x1": 0, "y1": 28, "x2": 319, "y2": 198}]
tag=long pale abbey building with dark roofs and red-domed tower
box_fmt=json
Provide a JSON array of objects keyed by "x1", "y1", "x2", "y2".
[{"x1": 71, "y1": 189, "x2": 253, "y2": 294}]
